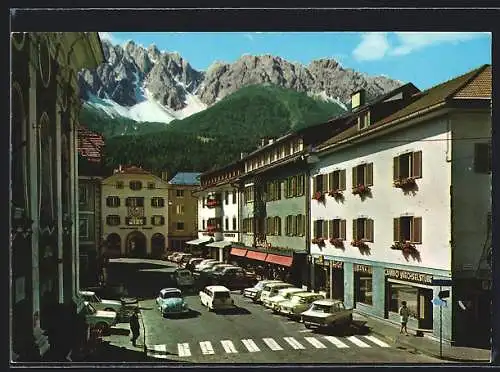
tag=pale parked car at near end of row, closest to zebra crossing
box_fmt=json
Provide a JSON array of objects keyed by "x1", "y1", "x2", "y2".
[{"x1": 301, "y1": 299, "x2": 352, "y2": 328}]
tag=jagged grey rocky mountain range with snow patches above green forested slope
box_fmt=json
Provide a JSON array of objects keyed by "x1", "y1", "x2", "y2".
[{"x1": 79, "y1": 40, "x2": 403, "y2": 123}]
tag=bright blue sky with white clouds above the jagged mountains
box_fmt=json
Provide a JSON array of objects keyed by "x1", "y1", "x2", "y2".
[{"x1": 100, "y1": 32, "x2": 491, "y2": 90}]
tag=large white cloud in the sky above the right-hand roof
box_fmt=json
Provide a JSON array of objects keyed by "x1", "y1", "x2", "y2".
[{"x1": 352, "y1": 32, "x2": 491, "y2": 61}]
